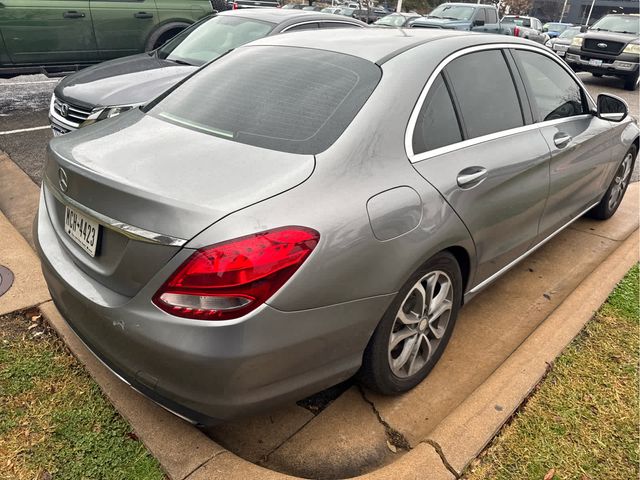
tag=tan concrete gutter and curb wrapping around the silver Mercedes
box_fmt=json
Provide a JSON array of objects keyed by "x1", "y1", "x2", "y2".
[{"x1": 0, "y1": 162, "x2": 640, "y2": 480}]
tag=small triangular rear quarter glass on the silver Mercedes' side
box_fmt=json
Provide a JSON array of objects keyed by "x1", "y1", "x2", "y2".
[{"x1": 413, "y1": 74, "x2": 462, "y2": 155}]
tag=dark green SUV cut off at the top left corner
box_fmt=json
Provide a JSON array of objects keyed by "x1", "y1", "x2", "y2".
[{"x1": 0, "y1": 0, "x2": 213, "y2": 75}]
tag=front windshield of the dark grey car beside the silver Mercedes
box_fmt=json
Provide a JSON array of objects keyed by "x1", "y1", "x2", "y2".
[{"x1": 158, "y1": 15, "x2": 274, "y2": 66}]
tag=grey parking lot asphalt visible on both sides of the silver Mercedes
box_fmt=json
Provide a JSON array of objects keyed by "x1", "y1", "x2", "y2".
[{"x1": 0, "y1": 73, "x2": 640, "y2": 185}]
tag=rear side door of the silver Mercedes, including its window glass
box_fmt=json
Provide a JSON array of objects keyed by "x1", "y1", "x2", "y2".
[{"x1": 407, "y1": 47, "x2": 549, "y2": 288}]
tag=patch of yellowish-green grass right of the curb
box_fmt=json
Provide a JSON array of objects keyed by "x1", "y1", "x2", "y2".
[{"x1": 465, "y1": 265, "x2": 640, "y2": 480}]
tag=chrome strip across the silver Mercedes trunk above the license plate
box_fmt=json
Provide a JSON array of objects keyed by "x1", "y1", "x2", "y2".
[{"x1": 44, "y1": 176, "x2": 187, "y2": 247}]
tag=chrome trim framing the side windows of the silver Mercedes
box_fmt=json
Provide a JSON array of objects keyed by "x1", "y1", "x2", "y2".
[{"x1": 404, "y1": 43, "x2": 595, "y2": 163}]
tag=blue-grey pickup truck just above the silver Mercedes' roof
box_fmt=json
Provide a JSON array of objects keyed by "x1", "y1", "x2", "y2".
[{"x1": 411, "y1": 3, "x2": 498, "y2": 30}]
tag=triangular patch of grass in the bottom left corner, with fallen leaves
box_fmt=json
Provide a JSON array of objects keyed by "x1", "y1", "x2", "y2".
[{"x1": 0, "y1": 314, "x2": 164, "y2": 480}]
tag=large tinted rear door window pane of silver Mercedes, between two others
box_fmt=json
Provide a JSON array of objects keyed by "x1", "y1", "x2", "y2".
[{"x1": 445, "y1": 50, "x2": 524, "y2": 138}]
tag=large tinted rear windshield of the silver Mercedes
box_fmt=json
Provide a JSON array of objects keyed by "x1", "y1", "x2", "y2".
[{"x1": 145, "y1": 46, "x2": 381, "y2": 155}]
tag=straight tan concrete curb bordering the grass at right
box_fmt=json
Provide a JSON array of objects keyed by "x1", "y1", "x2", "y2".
[{"x1": 422, "y1": 230, "x2": 640, "y2": 475}]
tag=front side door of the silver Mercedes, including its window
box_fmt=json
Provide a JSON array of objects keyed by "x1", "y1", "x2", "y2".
[{"x1": 513, "y1": 49, "x2": 615, "y2": 238}]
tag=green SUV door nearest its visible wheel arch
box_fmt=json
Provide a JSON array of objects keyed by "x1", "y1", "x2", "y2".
[{"x1": 91, "y1": 0, "x2": 158, "y2": 60}]
